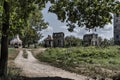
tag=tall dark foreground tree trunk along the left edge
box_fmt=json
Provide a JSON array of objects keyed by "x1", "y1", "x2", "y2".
[{"x1": 0, "y1": 0, "x2": 10, "y2": 80}]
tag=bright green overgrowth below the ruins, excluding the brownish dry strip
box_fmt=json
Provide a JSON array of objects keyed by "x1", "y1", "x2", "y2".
[{"x1": 37, "y1": 46, "x2": 120, "y2": 70}]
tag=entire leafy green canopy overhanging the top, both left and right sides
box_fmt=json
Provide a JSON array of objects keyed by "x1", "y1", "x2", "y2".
[{"x1": 0, "y1": 0, "x2": 120, "y2": 33}]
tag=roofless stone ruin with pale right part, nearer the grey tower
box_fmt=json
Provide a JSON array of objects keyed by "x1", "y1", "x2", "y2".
[{"x1": 83, "y1": 33, "x2": 99, "y2": 46}]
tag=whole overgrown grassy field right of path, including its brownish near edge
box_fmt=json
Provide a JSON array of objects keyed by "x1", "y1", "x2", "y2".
[{"x1": 36, "y1": 46, "x2": 120, "y2": 78}]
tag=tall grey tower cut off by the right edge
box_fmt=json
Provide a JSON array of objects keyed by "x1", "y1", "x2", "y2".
[{"x1": 114, "y1": 15, "x2": 120, "y2": 45}]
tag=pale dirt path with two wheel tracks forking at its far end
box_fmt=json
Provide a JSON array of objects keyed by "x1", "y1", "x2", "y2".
[{"x1": 15, "y1": 50, "x2": 87, "y2": 80}]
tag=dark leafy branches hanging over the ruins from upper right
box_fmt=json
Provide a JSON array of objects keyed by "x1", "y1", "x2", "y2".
[{"x1": 49, "y1": 0, "x2": 120, "y2": 31}]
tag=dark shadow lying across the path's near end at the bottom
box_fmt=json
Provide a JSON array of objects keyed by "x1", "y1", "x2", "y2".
[{"x1": 23, "y1": 77, "x2": 73, "y2": 80}]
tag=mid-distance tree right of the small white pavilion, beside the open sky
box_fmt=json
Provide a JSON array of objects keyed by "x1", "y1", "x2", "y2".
[{"x1": 21, "y1": 7, "x2": 48, "y2": 47}]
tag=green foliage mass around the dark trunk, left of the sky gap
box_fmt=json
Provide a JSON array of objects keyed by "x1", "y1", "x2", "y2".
[{"x1": 0, "y1": 0, "x2": 46, "y2": 34}]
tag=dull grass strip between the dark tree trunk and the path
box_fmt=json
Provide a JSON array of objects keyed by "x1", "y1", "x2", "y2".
[{"x1": 7, "y1": 48, "x2": 23, "y2": 80}]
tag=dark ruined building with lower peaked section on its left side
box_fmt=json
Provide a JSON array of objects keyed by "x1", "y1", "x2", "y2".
[{"x1": 44, "y1": 32, "x2": 64, "y2": 47}]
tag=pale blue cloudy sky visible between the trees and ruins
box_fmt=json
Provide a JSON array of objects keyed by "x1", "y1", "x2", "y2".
[{"x1": 41, "y1": 3, "x2": 113, "y2": 41}]
